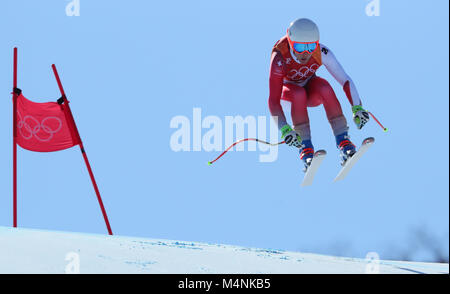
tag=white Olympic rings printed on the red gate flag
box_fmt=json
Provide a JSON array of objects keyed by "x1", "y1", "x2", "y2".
[{"x1": 17, "y1": 112, "x2": 63, "y2": 142}]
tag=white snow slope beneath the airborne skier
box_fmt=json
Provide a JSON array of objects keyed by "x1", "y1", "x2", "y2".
[{"x1": 0, "y1": 227, "x2": 449, "y2": 274}]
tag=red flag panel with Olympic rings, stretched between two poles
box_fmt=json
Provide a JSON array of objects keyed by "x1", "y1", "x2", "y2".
[{"x1": 16, "y1": 94, "x2": 80, "y2": 152}]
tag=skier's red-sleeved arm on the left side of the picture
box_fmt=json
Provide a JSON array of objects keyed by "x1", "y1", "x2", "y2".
[{"x1": 269, "y1": 52, "x2": 287, "y2": 130}]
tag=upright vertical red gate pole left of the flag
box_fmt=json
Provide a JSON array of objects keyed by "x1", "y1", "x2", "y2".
[{"x1": 12, "y1": 48, "x2": 17, "y2": 228}]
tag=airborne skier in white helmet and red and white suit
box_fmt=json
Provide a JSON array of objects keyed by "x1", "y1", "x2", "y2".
[{"x1": 269, "y1": 18, "x2": 369, "y2": 172}]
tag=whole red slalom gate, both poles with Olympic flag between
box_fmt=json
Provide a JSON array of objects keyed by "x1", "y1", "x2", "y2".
[{"x1": 11, "y1": 48, "x2": 112, "y2": 235}]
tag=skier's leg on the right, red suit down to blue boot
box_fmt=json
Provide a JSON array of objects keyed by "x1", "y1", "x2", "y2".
[{"x1": 305, "y1": 76, "x2": 355, "y2": 162}]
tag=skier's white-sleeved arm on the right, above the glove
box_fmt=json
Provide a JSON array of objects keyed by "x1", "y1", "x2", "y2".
[{"x1": 320, "y1": 44, "x2": 361, "y2": 106}]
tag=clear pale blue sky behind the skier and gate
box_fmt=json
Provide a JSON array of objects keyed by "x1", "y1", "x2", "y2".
[{"x1": 0, "y1": 0, "x2": 449, "y2": 259}]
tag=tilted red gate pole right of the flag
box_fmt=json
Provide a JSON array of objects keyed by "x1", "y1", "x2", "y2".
[{"x1": 52, "y1": 64, "x2": 113, "y2": 235}]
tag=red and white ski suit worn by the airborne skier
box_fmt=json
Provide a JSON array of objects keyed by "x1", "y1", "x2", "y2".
[{"x1": 269, "y1": 37, "x2": 361, "y2": 140}]
